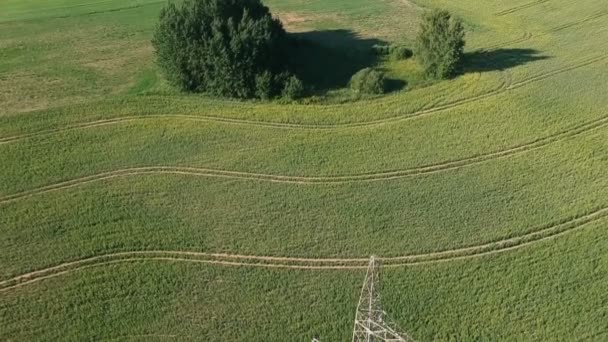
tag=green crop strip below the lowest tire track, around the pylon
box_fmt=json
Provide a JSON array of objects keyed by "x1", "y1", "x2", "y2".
[{"x1": 0, "y1": 219, "x2": 608, "y2": 341}]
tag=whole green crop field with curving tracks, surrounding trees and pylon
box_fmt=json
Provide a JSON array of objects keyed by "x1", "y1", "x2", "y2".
[{"x1": 0, "y1": 0, "x2": 608, "y2": 342}]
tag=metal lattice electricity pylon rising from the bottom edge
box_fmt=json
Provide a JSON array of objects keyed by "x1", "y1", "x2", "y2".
[{"x1": 353, "y1": 256, "x2": 414, "y2": 342}]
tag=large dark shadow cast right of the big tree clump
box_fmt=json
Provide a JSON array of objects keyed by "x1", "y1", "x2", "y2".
[{"x1": 289, "y1": 30, "x2": 405, "y2": 93}]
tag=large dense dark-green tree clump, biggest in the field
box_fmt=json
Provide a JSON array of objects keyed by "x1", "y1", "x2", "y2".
[{"x1": 152, "y1": 0, "x2": 287, "y2": 98}]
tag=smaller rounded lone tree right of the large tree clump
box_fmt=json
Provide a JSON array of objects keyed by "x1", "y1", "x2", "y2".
[{"x1": 416, "y1": 10, "x2": 465, "y2": 79}]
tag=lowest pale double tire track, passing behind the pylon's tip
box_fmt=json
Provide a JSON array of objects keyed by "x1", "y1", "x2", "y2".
[{"x1": 0, "y1": 207, "x2": 608, "y2": 292}]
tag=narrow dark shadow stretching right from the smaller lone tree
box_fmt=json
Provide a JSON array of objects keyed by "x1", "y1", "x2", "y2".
[{"x1": 461, "y1": 49, "x2": 550, "y2": 74}]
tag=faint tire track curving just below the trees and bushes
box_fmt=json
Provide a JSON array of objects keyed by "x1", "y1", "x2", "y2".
[{"x1": 0, "y1": 55, "x2": 608, "y2": 141}]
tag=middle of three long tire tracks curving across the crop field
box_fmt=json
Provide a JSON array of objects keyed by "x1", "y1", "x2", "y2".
[{"x1": 0, "y1": 116, "x2": 608, "y2": 205}]
